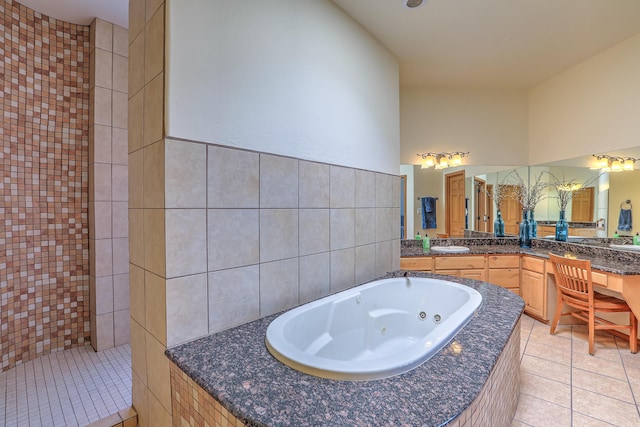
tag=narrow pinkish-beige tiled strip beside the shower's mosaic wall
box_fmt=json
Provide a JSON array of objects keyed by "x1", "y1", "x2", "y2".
[{"x1": 89, "y1": 19, "x2": 130, "y2": 351}]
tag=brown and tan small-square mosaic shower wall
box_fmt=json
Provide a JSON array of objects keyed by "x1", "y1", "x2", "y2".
[{"x1": 0, "y1": 0, "x2": 90, "y2": 370}]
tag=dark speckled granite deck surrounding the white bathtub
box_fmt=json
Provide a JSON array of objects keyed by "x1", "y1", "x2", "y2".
[{"x1": 166, "y1": 272, "x2": 524, "y2": 426}]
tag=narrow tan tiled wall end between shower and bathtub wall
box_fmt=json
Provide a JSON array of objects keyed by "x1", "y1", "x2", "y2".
[{"x1": 129, "y1": 0, "x2": 171, "y2": 427}]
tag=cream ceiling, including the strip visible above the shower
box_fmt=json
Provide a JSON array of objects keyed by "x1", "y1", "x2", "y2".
[{"x1": 13, "y1": 0, "x2": 640, "y2": 89}]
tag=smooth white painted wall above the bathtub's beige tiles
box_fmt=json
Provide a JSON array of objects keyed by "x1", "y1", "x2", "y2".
[{"x1": 166, "y1": 0, "x2": 400, "y2": 174}]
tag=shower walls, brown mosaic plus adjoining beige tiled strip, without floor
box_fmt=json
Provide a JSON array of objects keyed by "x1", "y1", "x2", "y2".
[{"x1": 0, "y1": 1, "x2": 129, "y2": 371}]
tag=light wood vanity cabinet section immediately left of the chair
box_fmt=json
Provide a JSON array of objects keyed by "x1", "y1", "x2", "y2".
[{"x1": 520, "y1": 255, "x2": 549, "y2": 321}]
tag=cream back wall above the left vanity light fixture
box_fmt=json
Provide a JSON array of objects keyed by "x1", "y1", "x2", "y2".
[{"x1": 400, "y1": 88, "x2": 528, "y2": 165}]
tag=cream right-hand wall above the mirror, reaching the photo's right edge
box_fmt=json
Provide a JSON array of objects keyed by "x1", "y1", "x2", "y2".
[{"x1": 529, "y1": 34, "x2": 640, "y2": 164}]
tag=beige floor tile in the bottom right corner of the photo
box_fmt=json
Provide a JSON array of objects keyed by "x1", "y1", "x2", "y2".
[{"x1": 572, "y1": 387, "x2": 640, "y2": 427}]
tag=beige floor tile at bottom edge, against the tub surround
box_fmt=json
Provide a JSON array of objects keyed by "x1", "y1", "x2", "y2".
[{"x1": 514, "y1": 393, "x2": 571, "y2": 427}]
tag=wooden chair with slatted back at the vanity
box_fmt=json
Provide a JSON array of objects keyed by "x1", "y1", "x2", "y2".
[{"x1": 549, "y1": 254, "x2": 638, "y2": 355}]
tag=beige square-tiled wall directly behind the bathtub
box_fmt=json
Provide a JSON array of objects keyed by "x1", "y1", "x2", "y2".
[{"x1": 164, "y1": 139, "x2": 400, "y2": 346}]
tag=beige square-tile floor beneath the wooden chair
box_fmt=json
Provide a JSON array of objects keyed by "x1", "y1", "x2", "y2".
[{"x1": 512, "y1": 316, "x2": 640, "y2": 427}]
